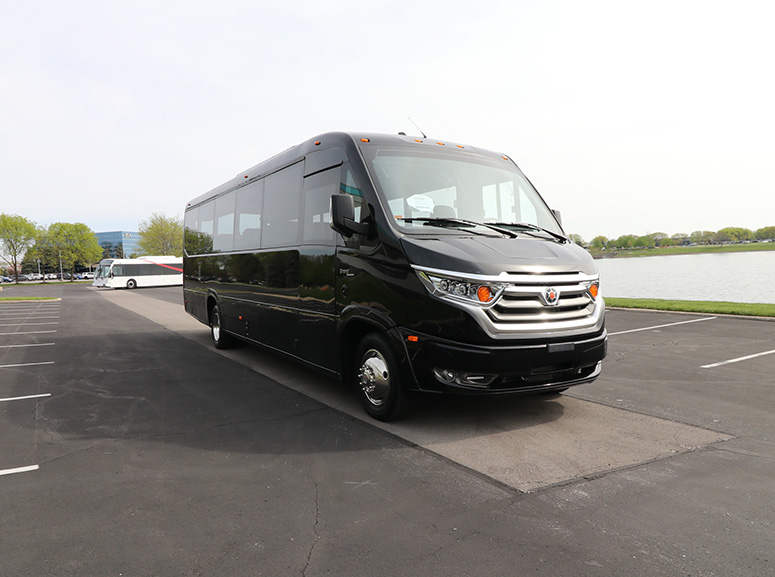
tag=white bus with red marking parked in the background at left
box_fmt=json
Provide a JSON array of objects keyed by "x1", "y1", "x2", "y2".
[{"x1": 92, "y1": 256, "x2": 183, "y2": 289}]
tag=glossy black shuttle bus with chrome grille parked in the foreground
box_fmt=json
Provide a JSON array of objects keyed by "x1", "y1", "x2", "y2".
[{"x1": 183, "y1": 133, "x2": 607, "y2": 420}]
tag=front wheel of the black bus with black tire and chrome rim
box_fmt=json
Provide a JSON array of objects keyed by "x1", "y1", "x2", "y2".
[{"x1": 354, "y1": 333, "x2": 415, "y2": 421}]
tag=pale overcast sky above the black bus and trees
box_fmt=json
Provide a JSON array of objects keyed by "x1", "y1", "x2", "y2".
[{"x1": 0, "y1": 0, "x2": 775, "y2": 240}]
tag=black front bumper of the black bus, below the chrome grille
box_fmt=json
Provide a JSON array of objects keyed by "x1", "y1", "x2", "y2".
[{"x1": 399, "y1": 329, "x2": 608, "y2": 394}]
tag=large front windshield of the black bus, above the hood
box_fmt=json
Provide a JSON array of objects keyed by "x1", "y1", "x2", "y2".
[{"x1": 362, "y1": 146, "x2": 564, "y2": 240}]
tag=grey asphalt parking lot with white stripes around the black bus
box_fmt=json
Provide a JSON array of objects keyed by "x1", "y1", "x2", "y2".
[{"x1": 0, "y1": 284, "x2": 775, "y2": 577}]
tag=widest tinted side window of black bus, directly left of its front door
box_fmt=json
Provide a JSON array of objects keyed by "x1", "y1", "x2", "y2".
[{"x1": 261, "y1": 162, "x2": 303, "y2": 248}]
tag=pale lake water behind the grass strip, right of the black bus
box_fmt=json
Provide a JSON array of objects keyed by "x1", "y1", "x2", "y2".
[{"x1": 595, "y1": 251, "x2": 775, "y2": 304}]
